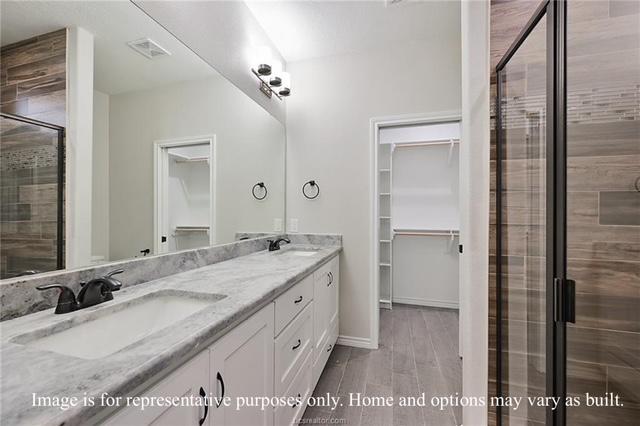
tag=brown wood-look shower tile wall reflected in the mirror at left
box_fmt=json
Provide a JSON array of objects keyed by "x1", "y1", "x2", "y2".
[{"x1": 0, "y1": 29, "x2": 66, "y2": 278}]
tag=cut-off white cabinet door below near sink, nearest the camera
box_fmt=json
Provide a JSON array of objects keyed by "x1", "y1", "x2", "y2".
[{"x1": 104, "y1": 350, "x2": 211, "y2": 426}]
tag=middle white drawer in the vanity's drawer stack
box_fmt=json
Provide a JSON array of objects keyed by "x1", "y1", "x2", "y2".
[{"x1": 275, "y1": 302, "x2": 313, "y2": 395}]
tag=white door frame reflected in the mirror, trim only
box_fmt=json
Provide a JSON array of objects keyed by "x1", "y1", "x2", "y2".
[{"x1": 153, "y1": 135, "x2": 218, "y2": 254}]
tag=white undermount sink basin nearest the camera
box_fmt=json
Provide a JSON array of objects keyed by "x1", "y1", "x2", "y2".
[{"x1": 12, "y1": 290, "x2": 226, "y2": 359}]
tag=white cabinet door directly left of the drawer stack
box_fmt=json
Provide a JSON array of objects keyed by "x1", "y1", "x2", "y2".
[{"x1": 211, "y1": 303, "x2": 274, "y2": 426}]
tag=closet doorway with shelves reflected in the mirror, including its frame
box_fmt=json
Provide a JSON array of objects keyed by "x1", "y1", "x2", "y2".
[{"x1": 154, "y1": 136, "x2": 216, "y2": 254}]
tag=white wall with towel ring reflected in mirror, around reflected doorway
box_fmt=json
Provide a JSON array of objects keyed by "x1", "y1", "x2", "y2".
[{"x1": 109, "y1": 76, "x2": 285, "y2": 259}]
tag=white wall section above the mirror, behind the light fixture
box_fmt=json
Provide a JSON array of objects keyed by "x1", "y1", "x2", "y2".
[{"x1": 134, "y1": 0, "x2": 286, "y2": 124}]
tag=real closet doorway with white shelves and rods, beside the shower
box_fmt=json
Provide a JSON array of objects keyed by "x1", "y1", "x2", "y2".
[{"x1": 372, "y1": 112, "x2": 463, "y2": 352}]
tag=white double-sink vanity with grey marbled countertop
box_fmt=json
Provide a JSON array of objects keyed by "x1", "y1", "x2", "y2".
[{"x1": 0, "y1": 244, "x2": 342, "y2": 425}]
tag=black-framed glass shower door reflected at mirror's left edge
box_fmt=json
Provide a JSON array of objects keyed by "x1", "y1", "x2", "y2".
[{"x1": 0, "y1": 113, "x2": 64, "y2": 279}]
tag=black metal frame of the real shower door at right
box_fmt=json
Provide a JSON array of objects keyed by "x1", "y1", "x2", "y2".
[{"x1": 495, "y1": 0, "x2": 574, "y2": 426}]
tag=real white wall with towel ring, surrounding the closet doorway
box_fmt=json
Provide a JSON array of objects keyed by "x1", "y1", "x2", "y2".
[{"x1": 286, "y1": 32, "x2": 460, "y2": 344}]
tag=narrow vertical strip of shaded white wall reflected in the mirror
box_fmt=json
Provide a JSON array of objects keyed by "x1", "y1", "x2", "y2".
[{"x1": 91, "y1": 90, "x2": 109, "y2": 260}]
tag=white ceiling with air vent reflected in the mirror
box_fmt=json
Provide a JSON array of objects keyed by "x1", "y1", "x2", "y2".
[{"x1": 0, "y1": 1, "x2": 217, "y2": 95}]
